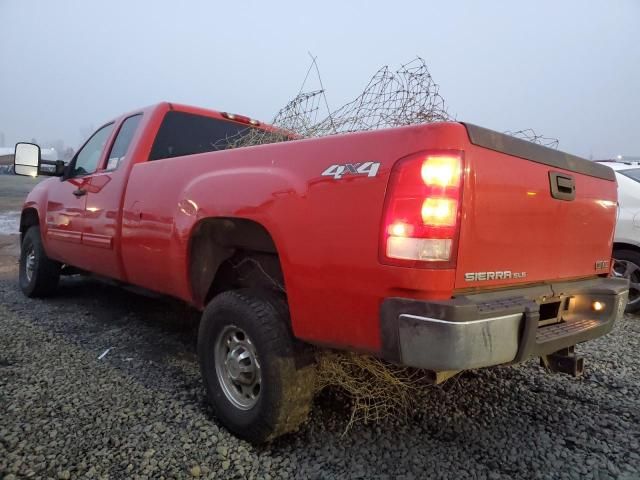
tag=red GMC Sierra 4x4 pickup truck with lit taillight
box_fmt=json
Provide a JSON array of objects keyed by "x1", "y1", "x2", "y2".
[{"x1": 14, "y1": 103, "x2": 628, "y2": 442}]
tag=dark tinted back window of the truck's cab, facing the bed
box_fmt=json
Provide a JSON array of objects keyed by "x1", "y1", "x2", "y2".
[{"x1": 149, "y1": 110, "x2": 282, "y2": 160}]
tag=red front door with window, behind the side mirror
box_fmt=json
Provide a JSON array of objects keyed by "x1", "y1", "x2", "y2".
[{"x1": 45, "y1": 123, "x2": 113, "y2": 268}]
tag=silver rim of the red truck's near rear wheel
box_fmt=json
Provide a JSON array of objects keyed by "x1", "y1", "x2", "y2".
[{"x1": 214, "y1": 325, "x2": 262, "y2": 410}]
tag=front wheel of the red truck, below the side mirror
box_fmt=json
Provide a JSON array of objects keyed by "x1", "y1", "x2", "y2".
[{"x1": 18, "y1": 227, "x2": 61, "y2": 297}]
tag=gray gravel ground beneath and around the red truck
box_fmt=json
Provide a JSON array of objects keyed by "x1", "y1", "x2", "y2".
[{"x1": 0, "y1": 177, "x2": 640, "y2": 480}]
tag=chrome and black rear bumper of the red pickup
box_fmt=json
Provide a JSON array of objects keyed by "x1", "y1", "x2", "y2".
[{"x1": 380, "y1": 278, "x2": 628, "y2": 371}]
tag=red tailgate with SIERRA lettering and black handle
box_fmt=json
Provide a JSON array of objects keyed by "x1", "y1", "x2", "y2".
[{"x1": 455, "y1": 124, "x2": 617, "y2": 290}]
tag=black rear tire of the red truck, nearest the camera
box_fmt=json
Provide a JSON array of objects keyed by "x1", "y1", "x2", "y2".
[{"x1": 198, "y1": 289, "x2": 315, "y2": 443}]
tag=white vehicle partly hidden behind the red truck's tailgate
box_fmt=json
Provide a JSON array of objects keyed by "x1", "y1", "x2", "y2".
[{"x1": 597, "y1": 157, "x2": 640, "y2": 313}]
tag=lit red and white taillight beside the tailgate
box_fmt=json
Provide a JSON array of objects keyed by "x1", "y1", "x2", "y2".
[{"x1": 380, "y1": 150, "x2": 464, "y2": 267}]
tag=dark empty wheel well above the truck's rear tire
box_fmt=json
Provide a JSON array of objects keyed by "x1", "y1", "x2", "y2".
[{"x1": 189, "y1": 218, "x2": 284, "y2": 305}]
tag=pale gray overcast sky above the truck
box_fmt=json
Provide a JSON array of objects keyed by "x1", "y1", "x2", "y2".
[{"x1": 0, "y1": 0, "x2": 640, "y2": 158}]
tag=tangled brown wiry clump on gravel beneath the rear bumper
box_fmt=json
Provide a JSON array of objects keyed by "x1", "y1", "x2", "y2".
[{"x1": 316, "y1": 351, "x2": 428, "y2": 430}]
